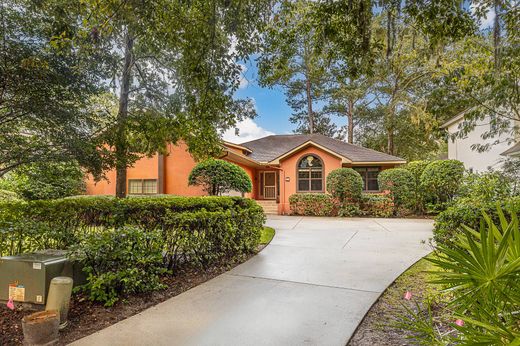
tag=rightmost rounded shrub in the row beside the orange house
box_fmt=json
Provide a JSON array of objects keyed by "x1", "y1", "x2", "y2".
[{"x1": 421, "y1": 160, "x2": 464, "y2": 203}]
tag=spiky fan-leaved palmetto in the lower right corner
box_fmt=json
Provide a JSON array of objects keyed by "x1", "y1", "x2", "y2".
[{"x1": 407, "y1": 208, "x2": 520, "y2": 345}]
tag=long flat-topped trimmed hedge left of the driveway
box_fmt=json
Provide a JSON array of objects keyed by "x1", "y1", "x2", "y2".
[{"x1": 0, "y1": 197, "x2": 265, "y2": 269}]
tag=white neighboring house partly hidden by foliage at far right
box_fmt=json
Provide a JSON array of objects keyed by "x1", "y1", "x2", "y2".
[{"x1": 441, "y1": 112, "x2": 520, "y2": 172}]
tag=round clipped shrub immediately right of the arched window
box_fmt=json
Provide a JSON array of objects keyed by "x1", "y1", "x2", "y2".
[{"x1": 327, "y1": 168, "x2": 363, "y2": 203}]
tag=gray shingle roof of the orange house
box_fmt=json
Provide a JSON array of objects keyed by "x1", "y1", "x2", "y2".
[{"x1": 240, "y1": 134, "x2": 405, "y2": 162}]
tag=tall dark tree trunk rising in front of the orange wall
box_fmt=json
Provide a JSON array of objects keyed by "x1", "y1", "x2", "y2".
[{"x1": 115, "y1": 32, "x2": 134, "y2": 198}]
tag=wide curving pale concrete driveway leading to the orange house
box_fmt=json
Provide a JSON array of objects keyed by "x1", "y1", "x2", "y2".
[{"x1": 71, "y1": 216, "x2": 432, "y2": 345}]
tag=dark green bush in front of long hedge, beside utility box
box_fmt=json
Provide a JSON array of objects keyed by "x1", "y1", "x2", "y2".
[{"x1": 70, "y1": 227, "x2": 166, "y2": 306}]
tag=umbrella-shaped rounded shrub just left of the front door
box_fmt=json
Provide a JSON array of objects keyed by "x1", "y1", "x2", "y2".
[{"x1": 188, "y1": 159, "x2": 253, "y2": 196}]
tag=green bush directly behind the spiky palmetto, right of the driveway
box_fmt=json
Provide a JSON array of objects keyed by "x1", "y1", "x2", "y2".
[{"x1": 433, "y1": 197, "x2": 520, "y2": 246}]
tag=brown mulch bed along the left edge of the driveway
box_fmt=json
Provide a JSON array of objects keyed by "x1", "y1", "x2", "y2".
[{"x1": 0, "y1": 255, "x2": 251, "y2": 346}]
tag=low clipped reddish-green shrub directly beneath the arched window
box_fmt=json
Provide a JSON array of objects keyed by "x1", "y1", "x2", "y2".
[{"x1": 289, "y1": 193, "x2": 338, "y2": 216}]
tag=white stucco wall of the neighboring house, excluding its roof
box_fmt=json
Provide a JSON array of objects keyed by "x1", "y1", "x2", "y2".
[{"x1": 447, "y1": 117, "x2": 511, "y2": 172}]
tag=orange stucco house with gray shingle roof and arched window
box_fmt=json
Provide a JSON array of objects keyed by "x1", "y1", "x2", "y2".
[{"x1": 87, "y1": 134, "x2": 406, "y2": 214}]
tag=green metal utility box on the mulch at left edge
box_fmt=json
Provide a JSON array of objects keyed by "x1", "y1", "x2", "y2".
[{"x1": 0, "y1": 250, "x2": 84, "y2": 304}]
